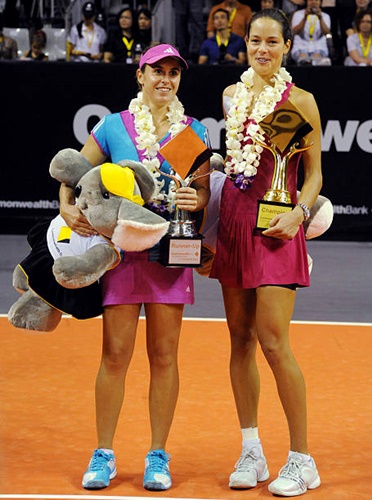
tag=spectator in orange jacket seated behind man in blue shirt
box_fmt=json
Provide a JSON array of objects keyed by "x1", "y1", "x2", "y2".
[{"x1": 207, "y1": 0, "x2": 252, "y2": 38}]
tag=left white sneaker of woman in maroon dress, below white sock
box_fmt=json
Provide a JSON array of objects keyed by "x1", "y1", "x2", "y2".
[{"x1": 229, "y1": 446, "x2": 269, "y2": 490}]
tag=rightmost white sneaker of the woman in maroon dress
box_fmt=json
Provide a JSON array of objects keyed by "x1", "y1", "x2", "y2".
[{"x1": 269, "y1": 453, "x2": 320, "y2": 497}]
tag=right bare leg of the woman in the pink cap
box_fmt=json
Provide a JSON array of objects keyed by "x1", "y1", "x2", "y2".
[{"x1": 145, "y1": 304, "x2": 184, "y2": 450}]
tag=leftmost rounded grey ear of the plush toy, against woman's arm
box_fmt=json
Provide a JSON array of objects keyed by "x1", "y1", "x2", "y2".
[{"x1": 49, "y1": 148, "x2": 92, "y2": 187}]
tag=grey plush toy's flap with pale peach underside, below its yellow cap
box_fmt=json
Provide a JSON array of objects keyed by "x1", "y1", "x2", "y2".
[{"x1": 111, "y1": 199, "x2": 169, "y2": 252}]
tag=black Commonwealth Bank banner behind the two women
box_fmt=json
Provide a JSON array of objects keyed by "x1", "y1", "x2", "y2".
[{"x1": 0, "y1": 61, "x2": 372, "y2": 241}]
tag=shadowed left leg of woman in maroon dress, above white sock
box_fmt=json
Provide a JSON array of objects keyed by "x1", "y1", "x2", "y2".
[{"x1": 222, "y1": 286, "x2": 260, "y2": 429}]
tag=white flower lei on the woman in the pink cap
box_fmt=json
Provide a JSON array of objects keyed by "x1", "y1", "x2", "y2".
[{"x1": 128, "y1": 92, "x2": 187, "y2": 212}]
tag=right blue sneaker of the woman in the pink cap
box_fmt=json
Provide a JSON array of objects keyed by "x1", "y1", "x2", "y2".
[{"x1": 143, "y1": 450, "x2": 172, "y2": 491}]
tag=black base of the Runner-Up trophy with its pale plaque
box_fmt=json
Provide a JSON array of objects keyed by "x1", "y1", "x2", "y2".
[{"x1": 160, "y1": 234, "x2": 203, "y2": 267}]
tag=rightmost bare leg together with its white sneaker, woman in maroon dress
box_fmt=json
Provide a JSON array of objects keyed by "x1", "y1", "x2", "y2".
[{"x1": 256, "y1": 286, "x2": 320, "y2": 497}]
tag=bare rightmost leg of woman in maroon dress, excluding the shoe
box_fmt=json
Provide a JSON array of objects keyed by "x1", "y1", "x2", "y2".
[{"x1": 256, "y1": 286, "x2": 308, "y2": 454}]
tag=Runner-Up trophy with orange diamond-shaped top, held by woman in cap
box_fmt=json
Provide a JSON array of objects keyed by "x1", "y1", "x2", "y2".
[{"x1": 159, "y1": 126, "x2": 212, "y2": 267}]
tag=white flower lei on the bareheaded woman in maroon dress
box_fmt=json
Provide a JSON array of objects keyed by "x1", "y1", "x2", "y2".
[{"x1": 225, "y1": 68, "x2": 292, "y2": 190}]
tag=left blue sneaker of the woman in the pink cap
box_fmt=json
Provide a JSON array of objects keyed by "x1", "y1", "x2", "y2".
[{"x1": 82, "y1": 449, "x2": 116, "y2": 490}]
